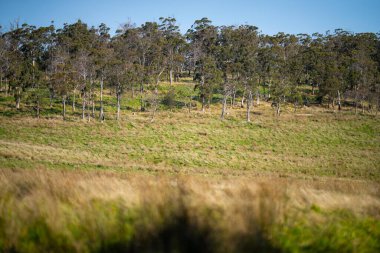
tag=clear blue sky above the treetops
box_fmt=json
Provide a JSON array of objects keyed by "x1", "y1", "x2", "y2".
[{"x1": 0, "y1": 0, "x2": 380, "y2": 34}]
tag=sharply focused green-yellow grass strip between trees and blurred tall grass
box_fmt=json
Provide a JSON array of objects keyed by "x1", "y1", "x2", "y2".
[{"x1": 0, "y1": 97, "x2": 380, "y2": 181}]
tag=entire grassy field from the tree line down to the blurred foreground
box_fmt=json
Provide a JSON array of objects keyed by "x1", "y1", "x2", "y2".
[{"x1": 0, "y1": 83, "x2": 380, "y2": 252}]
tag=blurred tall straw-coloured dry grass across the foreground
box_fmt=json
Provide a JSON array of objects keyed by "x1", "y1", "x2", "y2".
[{"x1": 0, "y1": 169, "x2": 380, "y2": 252}]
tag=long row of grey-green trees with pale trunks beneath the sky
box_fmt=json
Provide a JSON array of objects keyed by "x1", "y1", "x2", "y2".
[{"x1": 0, "y1": 17, "x2": 380, "y2": 121}]
